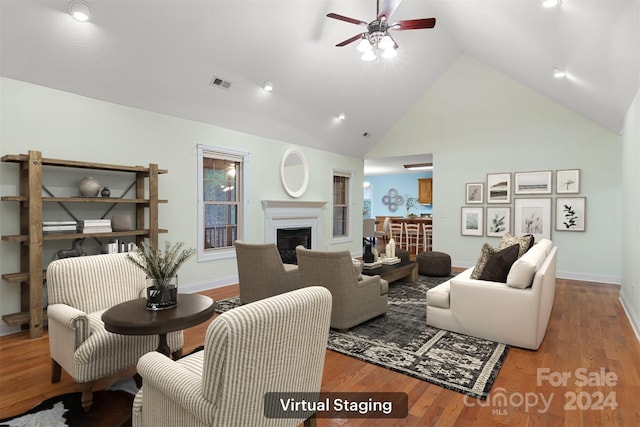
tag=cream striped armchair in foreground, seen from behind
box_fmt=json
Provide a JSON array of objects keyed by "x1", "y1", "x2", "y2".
[{"x1": 132, "y1": 286, "x2": 331, "y2": 427}]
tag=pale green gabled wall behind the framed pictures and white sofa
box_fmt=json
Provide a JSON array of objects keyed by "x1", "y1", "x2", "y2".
[{"x1": 366, "y1": 55, "x2": 626, "y2": 283}]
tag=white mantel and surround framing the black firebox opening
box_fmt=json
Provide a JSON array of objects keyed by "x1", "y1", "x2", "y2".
[{"x1": 262, "y1": 200, "x2": 327, "y2": 249}]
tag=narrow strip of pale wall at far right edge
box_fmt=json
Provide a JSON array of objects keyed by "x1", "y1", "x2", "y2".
[{"x1": 620, "y1": 92, "x2": 640, "y2": 340}]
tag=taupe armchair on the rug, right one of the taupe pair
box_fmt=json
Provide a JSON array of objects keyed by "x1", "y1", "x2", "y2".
[{"x1": 296, "y1": 246, "x2": 389, "y2": 330}]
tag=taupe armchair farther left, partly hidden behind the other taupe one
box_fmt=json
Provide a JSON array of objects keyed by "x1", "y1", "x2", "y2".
[{"x1": 235, "y1": 240, "x2": 300, "y2": 304}]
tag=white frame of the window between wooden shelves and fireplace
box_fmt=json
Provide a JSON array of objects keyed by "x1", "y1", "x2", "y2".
[{"x1": 196, "y1": 144, "x2": 249, "y2": 262}]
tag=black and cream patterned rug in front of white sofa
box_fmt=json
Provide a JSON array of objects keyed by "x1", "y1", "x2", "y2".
[{"x1": 216, "y1": 276, "x2": 509, "y2": 399}]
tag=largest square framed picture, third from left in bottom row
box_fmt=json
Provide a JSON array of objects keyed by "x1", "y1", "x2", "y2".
[{"x1": 513, "y1": 197, "x2": 551, "y2": 241}]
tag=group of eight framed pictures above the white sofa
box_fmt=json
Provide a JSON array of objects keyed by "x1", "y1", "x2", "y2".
[{"x1": 460, "y1": 169, "x2": 587, "y2": 241}]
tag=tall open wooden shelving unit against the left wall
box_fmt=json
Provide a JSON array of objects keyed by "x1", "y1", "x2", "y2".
[{"x1": 0, "y1": 151, "x2": 167, "y2": 338}]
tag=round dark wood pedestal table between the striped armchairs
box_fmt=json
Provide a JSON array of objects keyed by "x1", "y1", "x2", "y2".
[{"x1": 102, "y1": 294, "x2": 216, "y2": 356}]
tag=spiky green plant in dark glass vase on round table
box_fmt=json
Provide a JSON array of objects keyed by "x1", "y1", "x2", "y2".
[{"x1": 127, "y1": 242, "x2": 195, "y2": 310}]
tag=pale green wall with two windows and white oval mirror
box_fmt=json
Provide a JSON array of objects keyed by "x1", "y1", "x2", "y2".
[{"x1": 0, "y1": 78, "x2": 363, "y2": 332}]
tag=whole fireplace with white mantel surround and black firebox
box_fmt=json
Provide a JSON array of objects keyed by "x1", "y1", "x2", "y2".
[{"x1": 262, "y1": 200, "x2": 327, "y2": 264}]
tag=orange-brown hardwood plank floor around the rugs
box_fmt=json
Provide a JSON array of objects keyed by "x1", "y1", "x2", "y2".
[{"x1": 0, "y1": 279, "x2": 640, "y2": 427}]
